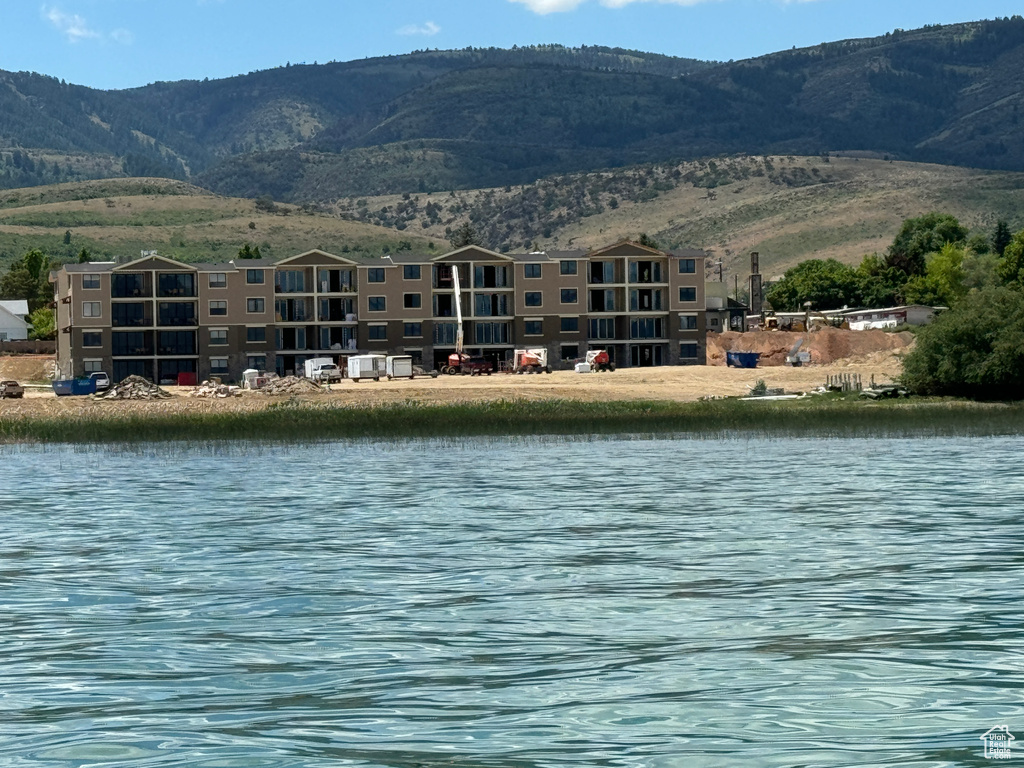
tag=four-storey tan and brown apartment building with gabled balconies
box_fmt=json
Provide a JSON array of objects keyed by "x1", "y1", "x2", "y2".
[{"x1": 51, "y1": 242, "x2": 706, "y2": 382}]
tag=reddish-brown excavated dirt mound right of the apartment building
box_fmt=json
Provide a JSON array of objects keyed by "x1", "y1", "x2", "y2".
[{"x1": 708, "y1": 328, "x2": 913, "y2": 366}]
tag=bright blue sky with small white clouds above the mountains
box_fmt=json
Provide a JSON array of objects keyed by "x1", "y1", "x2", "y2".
[{"x1": 0, "y1": 0, "x2": 1021, "y2": 88}]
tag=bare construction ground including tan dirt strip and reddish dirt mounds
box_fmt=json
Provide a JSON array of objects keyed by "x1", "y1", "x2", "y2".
[{"x1": 0, "y1": 329, "x2": 913, "y2": 418}]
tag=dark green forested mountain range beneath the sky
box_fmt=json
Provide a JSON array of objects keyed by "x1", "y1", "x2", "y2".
[{"x1": 0, "y1": 16, "x2": 1024, "y2": 203}]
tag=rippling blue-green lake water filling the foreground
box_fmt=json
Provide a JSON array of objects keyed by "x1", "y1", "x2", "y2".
[{"x1": 0, "y1": 438, "x2": 1024, "y2": 768}]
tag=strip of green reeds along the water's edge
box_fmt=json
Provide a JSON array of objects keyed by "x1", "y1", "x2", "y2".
[{"x1": 0, "y1": 396, "x2": 1024, "y2": 444}]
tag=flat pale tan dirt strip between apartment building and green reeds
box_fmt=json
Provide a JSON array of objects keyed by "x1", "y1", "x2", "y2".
[{"x1": 0, "y1": 352, "x2": 900, "y2": 419}]
